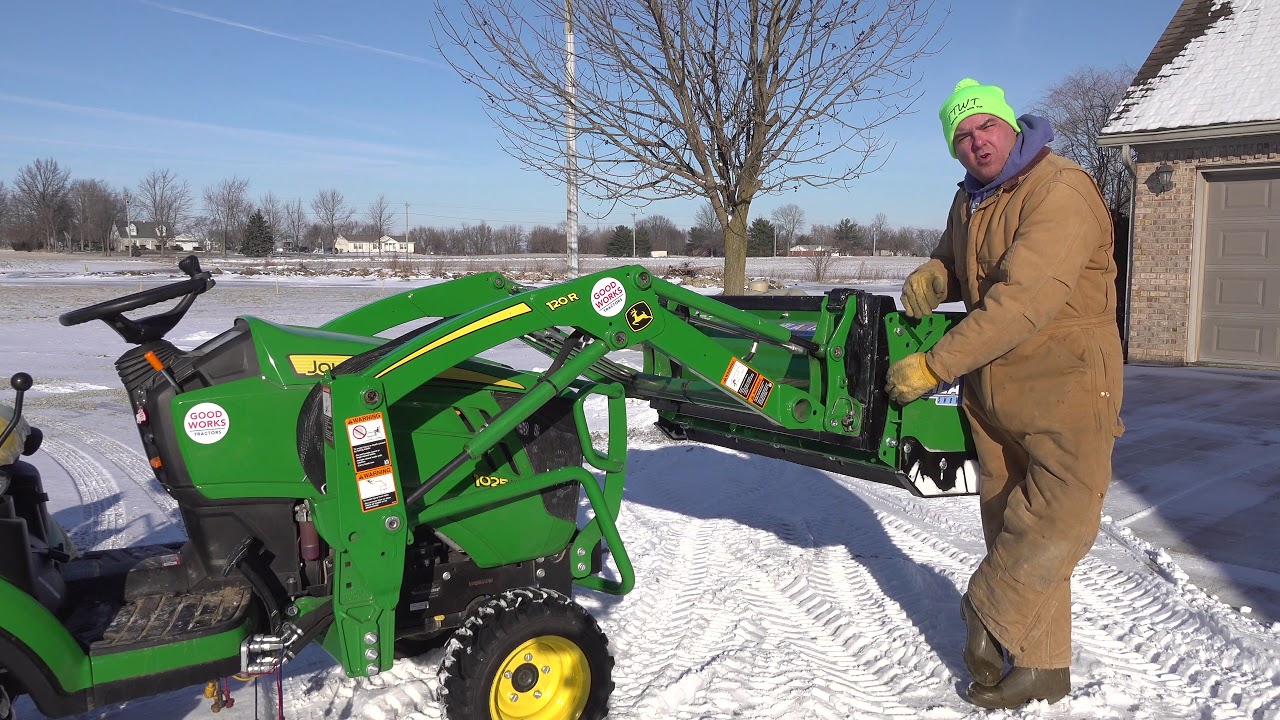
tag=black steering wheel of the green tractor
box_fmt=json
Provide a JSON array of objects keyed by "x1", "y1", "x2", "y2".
[{"x1": 58, "y1": 255, "x2": 214, "y2": 345}]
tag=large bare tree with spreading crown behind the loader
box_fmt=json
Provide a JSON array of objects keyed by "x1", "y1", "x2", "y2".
[{"x1": 433, "y1": 0, "x2": 937, "y2": 295}]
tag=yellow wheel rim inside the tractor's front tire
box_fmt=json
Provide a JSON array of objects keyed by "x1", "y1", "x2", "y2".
[{"x1": 489, "y1": 635, "x2": 591, "y2": 720}]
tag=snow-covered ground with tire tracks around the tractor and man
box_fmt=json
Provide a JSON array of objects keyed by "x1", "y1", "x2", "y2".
[{"x1": 0, "y1": 252, "x2": 1280, "y2": 720}]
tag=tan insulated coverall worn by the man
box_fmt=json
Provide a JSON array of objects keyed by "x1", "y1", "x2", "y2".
[{"x1": 925, "y1": 149, "x2": 1124, "y2": 669}]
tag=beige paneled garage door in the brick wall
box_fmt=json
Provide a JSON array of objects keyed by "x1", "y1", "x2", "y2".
[{"x1": 1199, "y1": 170, "x2": 1280, "y2": 369}]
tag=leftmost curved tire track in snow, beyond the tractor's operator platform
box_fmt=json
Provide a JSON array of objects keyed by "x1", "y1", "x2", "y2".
[{"x1": 40, "y1": 436, "x2": 128, "y2": 550}]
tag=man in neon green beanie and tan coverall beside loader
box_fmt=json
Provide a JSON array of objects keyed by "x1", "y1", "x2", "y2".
[{"x1": 886, "y1": 78, "x2": 1124, "y2": 708}]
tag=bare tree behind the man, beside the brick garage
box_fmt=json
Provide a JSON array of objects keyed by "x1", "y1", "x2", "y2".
[{"x1": 1032, "y1": 65, "x2": 1135, "y2": 217}]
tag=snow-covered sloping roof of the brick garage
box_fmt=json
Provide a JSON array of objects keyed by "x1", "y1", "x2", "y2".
[{"x1": 1102, "y1": 0, "x2": 1280, "y2": 137}]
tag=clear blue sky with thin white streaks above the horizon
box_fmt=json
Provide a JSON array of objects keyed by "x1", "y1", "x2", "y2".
[{"x1": 0, "y1": 0, "x2": 1179, "y2": 229}]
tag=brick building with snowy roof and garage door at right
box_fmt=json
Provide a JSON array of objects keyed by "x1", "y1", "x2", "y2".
[{"x1": 1098, "y1": 0, "x2": 1280, "y2": 370}]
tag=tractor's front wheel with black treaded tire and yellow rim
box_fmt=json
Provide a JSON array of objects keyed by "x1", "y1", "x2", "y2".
[{"x1": 440, "y1": 588, "x2": 613, "y2": 720}]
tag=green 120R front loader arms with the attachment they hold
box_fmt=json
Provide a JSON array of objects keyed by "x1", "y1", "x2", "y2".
[{"x1": 307, "y1": 266, "x2": 975, "y2": 671}]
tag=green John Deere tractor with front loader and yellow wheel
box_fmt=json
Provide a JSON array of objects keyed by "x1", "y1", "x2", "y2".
[{"x1": 0, "y1": 258, "x2": 977, "y2": 720}]
